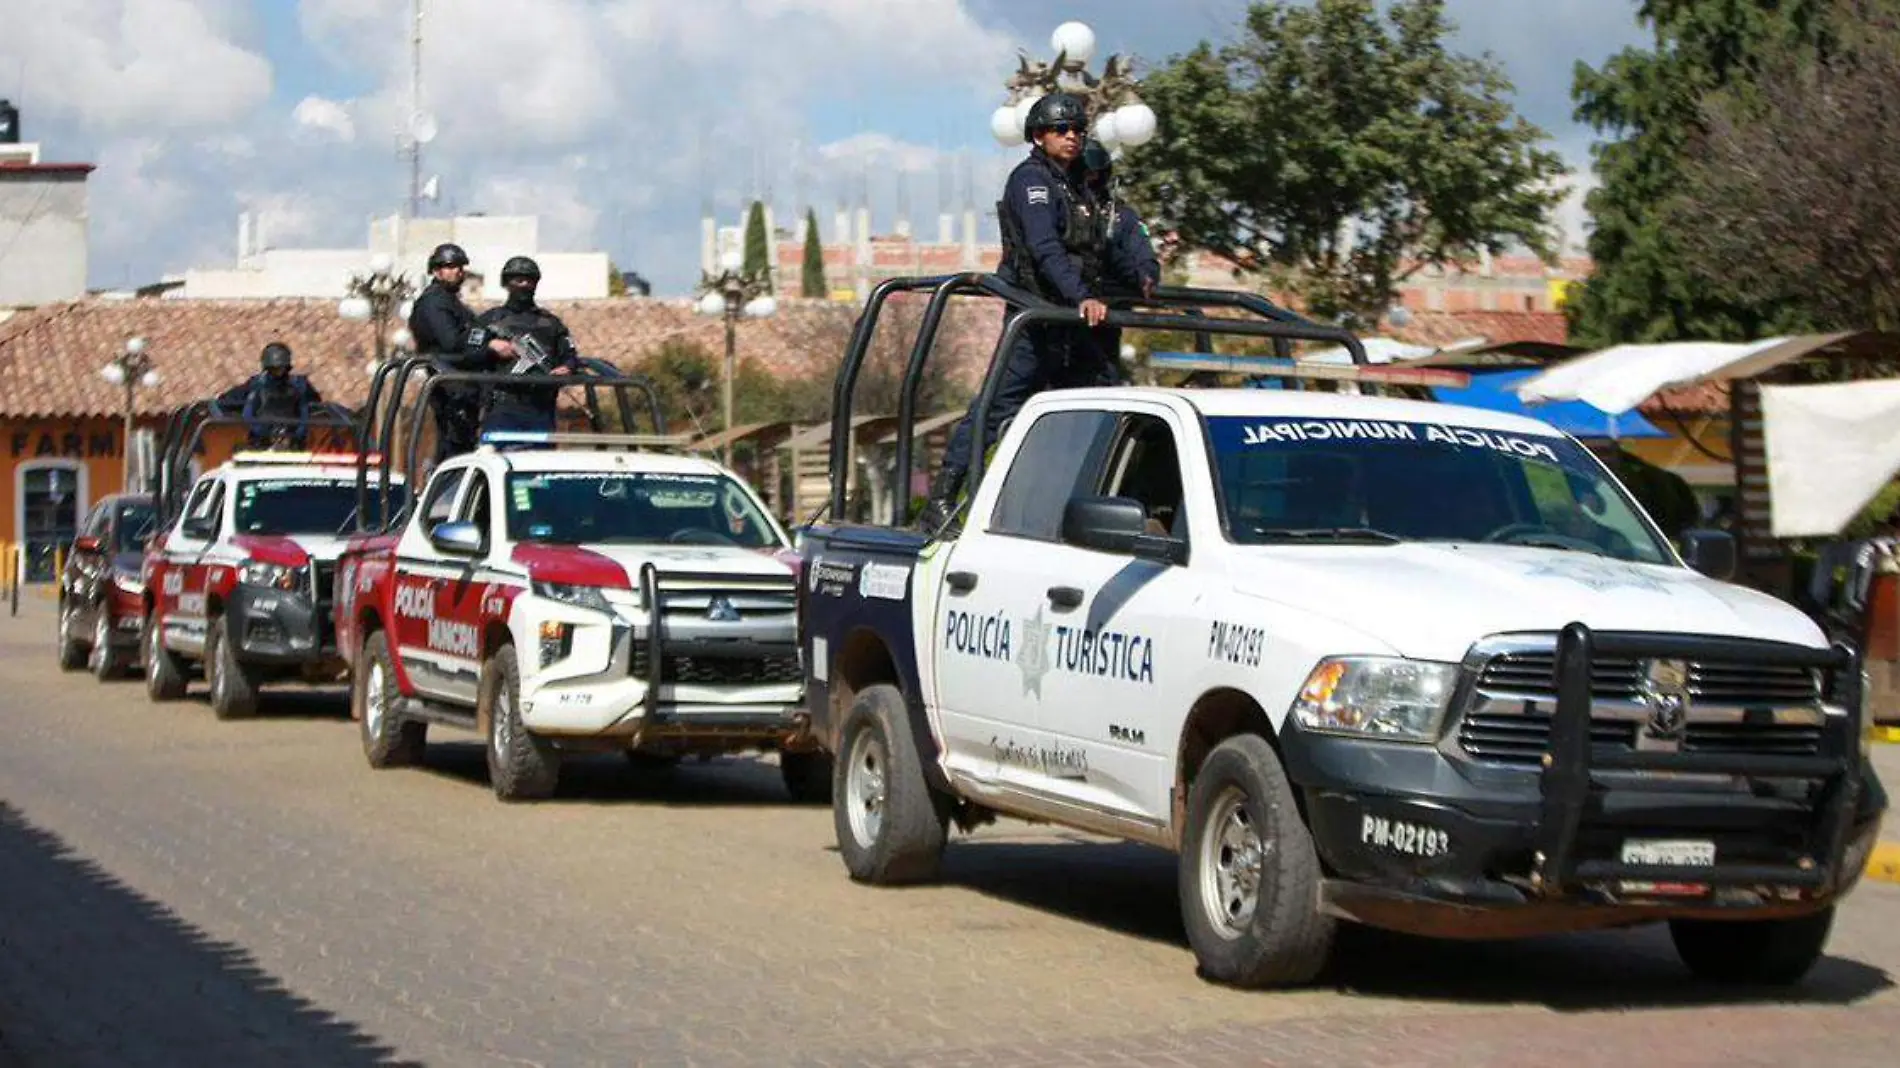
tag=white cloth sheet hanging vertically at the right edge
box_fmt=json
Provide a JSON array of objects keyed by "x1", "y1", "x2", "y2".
[{"x1": 1761, "y1": 378, "x2": 1900, "y2": 538}]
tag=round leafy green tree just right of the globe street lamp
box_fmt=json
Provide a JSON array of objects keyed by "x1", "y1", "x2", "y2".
[{"x1": 1125, "y1": 0, "x2": 1564, "y2": 323}]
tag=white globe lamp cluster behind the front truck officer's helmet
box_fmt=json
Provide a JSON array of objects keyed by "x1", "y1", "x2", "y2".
[{"x1": 990, "y1": 23, "x2": 1155, "y2": 156}]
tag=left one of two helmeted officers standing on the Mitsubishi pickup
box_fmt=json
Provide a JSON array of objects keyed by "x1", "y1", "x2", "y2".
[{"x1": 409, "y1": 243, "x2": 515, "y2": 464}]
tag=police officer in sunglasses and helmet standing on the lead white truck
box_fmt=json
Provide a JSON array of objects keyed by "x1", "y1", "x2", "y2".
[{"x1": 923, "y1": 93, "x2": 1113, "y2": 530}]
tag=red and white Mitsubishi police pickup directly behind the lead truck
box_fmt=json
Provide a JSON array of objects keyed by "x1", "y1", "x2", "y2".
[{"x1": 334, "y1": 433, "x2": 830, "y2": 800}]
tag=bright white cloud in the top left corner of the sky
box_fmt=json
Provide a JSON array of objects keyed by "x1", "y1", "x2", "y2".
[{"x1": 0, "y1": 0, "x2": 272, "y2": 135}]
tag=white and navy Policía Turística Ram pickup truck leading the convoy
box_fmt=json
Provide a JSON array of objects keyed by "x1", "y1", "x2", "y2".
[{"x1": 802, "y1": 388, "x2": 1885, "y2": 986}]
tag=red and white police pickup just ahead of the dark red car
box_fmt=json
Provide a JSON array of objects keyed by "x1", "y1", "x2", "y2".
[{"x1": 143, "y1": 452, "x2": 400, "y2": 718}]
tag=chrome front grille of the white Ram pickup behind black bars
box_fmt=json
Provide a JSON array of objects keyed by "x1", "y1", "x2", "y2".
[{"x1": 1457, "y1": 639, "x2": 1826, "y2": 766}]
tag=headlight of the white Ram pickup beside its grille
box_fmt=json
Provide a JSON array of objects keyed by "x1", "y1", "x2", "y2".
[{"x1": 1292, "y1": 656, "x2": 1457, "y2": 741}]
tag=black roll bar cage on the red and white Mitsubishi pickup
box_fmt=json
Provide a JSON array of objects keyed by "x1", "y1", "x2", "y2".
[{"x1": 357, "y1": 355, "x2": 667, "y2": 534}]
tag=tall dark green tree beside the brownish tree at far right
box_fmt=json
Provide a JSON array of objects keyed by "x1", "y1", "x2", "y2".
[{"x1": 1566, "y1": 0, "x2": 1826, "y2": 344}]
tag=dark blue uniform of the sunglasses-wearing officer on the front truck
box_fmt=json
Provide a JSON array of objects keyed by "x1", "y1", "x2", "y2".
[{"x1": 931, "y1": 148, "x2": 1119, "y2": 500}]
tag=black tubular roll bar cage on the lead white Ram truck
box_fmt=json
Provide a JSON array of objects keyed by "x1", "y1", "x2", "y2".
[{"x1": 827, "y1": 272, "x2": 1368, "y2": 517}]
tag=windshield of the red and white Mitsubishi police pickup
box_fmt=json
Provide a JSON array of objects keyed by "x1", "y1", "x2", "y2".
[{"x1": 507, "y1": 471, "x2": 779, "y2": 549}]
